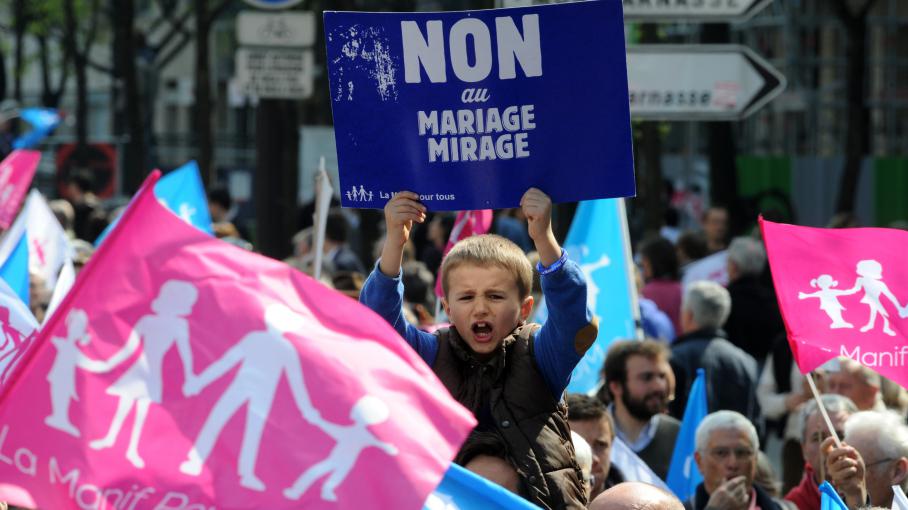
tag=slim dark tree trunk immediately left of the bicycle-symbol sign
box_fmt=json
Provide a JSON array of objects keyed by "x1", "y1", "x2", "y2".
[{"x1": 194, "y1": 0, "x2": 216, "y2": 186}]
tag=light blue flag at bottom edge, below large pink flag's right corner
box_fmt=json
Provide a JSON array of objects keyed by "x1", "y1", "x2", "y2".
[{"x1": 423, "y1": 464, "x2": 539, "y2": 510}]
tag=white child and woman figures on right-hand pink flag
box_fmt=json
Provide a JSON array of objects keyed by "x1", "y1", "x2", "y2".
[{"x1": 798, "y1": 259, "x2": 908, "y2": 336}]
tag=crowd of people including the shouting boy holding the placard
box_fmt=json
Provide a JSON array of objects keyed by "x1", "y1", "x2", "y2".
[{"x1": 31, "y1": 168, "x2": 908, "y2": 510}]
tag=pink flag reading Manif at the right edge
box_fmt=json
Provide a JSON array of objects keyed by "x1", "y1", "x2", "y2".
[{"x1": 760, "y1": 218, "x2": 908, "y2": 387}]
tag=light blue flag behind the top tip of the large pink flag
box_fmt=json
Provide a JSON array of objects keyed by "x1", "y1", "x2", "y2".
[{"x1": 95, "y1": 161, "x2": 214, "y2": 247}]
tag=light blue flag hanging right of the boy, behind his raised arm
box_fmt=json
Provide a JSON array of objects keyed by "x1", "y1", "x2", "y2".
[{"x1": 560, "y1": 199, "x2": 637, "y2": 394}]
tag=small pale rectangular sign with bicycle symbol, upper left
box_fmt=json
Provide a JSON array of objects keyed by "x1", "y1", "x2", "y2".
[{"x1": 236, "y1": 11, "x2": 315, "y2": 47}]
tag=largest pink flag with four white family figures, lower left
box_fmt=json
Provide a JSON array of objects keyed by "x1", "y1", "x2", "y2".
[{"x1": 0, "y1": 173, "x2": 475, "y2": 510}]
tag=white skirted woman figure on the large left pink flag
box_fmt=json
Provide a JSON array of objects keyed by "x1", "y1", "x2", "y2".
[{"x1": 89, "y1": 280, "x2": 199, "y2": 468}]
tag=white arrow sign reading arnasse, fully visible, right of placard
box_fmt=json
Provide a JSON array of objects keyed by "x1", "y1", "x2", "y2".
[{"x1": 627, "y1": 44, "x2": 786, "y2": 121}]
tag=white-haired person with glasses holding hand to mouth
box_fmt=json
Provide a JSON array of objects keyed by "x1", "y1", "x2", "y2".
[{"x1": 684, "y1": 411, "x2": 781, "y2": 510}]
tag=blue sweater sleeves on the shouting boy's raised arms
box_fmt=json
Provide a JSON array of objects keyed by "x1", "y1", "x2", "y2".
[{"x1": 359, "y1": 260, "x2": 593, "y2": 399}]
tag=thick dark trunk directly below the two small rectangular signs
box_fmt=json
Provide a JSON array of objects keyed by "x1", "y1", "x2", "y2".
[{"x1": 254, "y1": 99, "x2": 299, "y2": 259}]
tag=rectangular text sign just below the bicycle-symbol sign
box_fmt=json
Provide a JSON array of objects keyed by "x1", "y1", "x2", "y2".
[{"x1": 236, "y1": 48, "x2": 315, "y2": 99}]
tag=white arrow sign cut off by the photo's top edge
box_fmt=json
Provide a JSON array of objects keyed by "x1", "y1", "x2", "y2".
[{"x1": 624, "y1": 0, "x2": 772, "y2": 23}]
